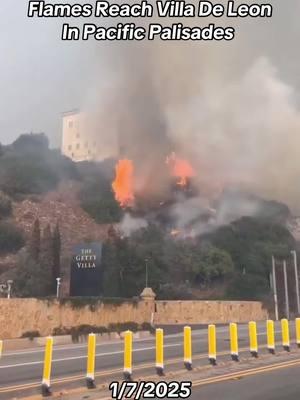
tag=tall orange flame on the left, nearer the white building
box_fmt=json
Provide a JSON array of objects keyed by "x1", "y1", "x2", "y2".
[{"x1": 112, "y1": 159, "x2": 134, "y2": 207}]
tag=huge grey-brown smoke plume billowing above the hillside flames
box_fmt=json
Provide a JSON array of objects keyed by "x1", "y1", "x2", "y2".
[{"x1": 85, "y1": 0, "x2": 300, "y2": 219}]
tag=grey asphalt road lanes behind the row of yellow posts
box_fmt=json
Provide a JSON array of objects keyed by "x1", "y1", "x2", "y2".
[{"x1": 0, "y1": 323, "x2": 294, "y2": 399}]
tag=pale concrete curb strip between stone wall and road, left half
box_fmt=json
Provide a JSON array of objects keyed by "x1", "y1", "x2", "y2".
[{"x1": 3, "y1": 331, "x2": 151, "y2": 352}]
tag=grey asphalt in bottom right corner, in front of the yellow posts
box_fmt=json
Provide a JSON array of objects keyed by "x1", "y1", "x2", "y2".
[{"x1": 191, "y1": 365, "x2": 300, "y2": 400}]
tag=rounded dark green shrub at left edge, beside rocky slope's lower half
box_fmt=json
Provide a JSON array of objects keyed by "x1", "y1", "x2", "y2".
[{"x1": 0, "y1": 222, "x2": 25, "y2": 254}]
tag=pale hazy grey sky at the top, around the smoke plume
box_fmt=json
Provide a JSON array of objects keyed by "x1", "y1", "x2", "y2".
[{"x1": 0, "y1": 0, "x2": 300, "y2": 146}]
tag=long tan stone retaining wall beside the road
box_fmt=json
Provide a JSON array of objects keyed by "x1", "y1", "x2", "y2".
[{"x1": 0, "y1": 299, "x2": 268, "y2": 339}]
